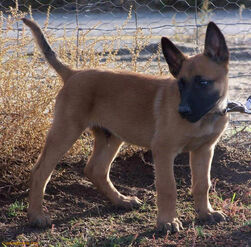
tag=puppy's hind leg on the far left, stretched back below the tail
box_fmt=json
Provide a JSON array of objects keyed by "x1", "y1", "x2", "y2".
[{"x1": 28, "y1": 111, "x2": 82, "y2": 227}]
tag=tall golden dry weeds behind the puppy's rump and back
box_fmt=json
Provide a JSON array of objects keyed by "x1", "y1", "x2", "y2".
[{"x1": 0, "y1": 6, "x2": 166, "y2": 168}]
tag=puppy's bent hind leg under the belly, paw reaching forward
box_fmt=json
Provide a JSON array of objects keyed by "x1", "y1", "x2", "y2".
[{"x1": 84, "y1": 127, "x2": 140, "y2": 208}]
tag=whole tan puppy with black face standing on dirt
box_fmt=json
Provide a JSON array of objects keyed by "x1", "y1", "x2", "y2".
[{"x1": 23, "y1": 18, "x2": 229, "y2": 232}]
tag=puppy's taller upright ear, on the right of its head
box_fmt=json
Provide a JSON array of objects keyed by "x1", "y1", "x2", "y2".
[{"x1": 204, "y1": 22, "x2": 229, "y2": 63}]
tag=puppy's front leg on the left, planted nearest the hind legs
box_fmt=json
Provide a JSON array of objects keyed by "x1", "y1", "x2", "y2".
[{"x1": 152, "y1": 143, "x2": 183, "y2": 233}]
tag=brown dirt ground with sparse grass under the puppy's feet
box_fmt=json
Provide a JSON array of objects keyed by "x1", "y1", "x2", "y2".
[{"x1": 0, "y1": 131, "x2": 251, "y2": 247}]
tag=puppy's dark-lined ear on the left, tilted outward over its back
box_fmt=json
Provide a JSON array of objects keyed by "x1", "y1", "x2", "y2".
[{"x1": 161, "y1": 37, "x2": 186, "y2": 77}]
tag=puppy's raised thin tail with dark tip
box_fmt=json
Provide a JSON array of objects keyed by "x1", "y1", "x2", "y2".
[{"x1": 22, "y1": 18, "x2": 73, "y2": 81}]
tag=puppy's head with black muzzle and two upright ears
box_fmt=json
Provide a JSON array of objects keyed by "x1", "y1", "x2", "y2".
[{"x1": 161, "y1": 22, "x2": 229, "y2": 123}]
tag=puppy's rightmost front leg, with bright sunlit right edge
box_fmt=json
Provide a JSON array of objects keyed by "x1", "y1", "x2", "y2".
[{"x1": 190, "y1": 145, "x2": 225, "y2": 223}]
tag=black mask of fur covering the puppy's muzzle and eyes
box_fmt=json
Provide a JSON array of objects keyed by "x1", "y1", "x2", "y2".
[{"x1": 178, "y1": 76, "x2": 220, "y2": 123}]
